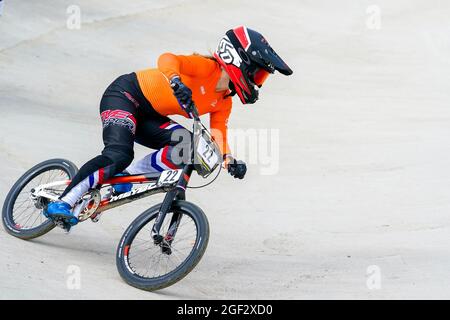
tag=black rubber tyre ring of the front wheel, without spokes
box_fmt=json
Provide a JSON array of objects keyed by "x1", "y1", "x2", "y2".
[{"x1": 116, "y1": 200, "x2": 209, "y2": 291}]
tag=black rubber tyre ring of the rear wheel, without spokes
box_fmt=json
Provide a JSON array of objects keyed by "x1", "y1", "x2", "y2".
[{"x1": 2, "y1": 159, "x2": 78, "y2": 240}]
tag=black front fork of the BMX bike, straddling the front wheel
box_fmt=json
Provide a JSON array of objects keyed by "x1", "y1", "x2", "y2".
[{"x1": 151, "y1": 164, "x2": 194, "y2": 244}]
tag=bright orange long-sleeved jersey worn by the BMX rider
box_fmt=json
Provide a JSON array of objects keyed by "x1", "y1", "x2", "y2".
[{"x1": 136, "y1": 53, "x2": 231, "y2": 154}]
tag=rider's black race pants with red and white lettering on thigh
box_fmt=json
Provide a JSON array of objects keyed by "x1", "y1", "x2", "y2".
[{"x1": 61, "y1": 73, "x2": 189, "y2": 201}]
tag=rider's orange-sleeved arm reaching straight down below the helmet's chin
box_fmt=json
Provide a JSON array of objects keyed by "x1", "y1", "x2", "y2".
[{"x1": 210, "y1": 97, "x2": 231, "y2": 155}]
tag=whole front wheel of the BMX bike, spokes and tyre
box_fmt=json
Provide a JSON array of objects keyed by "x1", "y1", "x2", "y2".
[{"x1": 116, "y1": 200, "x2": 209, "y2": 291}]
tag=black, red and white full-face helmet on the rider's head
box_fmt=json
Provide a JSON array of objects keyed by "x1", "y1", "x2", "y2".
[{"x1": 214, "y1": 26, "x2": 292, "y2": 104}]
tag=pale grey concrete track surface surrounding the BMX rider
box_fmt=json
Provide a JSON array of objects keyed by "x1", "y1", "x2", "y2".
[{"x1": 0, "y1": 0, "x2": 450, "y2": 299}]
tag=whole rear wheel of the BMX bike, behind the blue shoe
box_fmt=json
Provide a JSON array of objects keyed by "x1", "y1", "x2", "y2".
[{"x1": 2, "y1": 159, "x2": 78, "y2": 240}]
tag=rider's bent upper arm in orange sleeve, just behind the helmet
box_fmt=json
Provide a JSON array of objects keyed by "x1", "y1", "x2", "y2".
[{"x1": 158, "y1": 52, "x2": 216, "y2": 80}]
